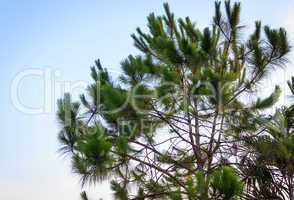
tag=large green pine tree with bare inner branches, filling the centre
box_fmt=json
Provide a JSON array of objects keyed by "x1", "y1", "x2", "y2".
[{"x1": 57, "y1": 1, "x2": 294, "y2": 200}]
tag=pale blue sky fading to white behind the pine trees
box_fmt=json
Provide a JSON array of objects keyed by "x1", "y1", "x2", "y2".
[{"x1": 0, "y1": 0, "x2": 294, "y2": 200}]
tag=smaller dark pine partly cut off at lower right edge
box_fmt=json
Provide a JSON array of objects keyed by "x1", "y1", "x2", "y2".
[{"x1": 240, "y1": 78, "x2": 294, "y2": 200}]
